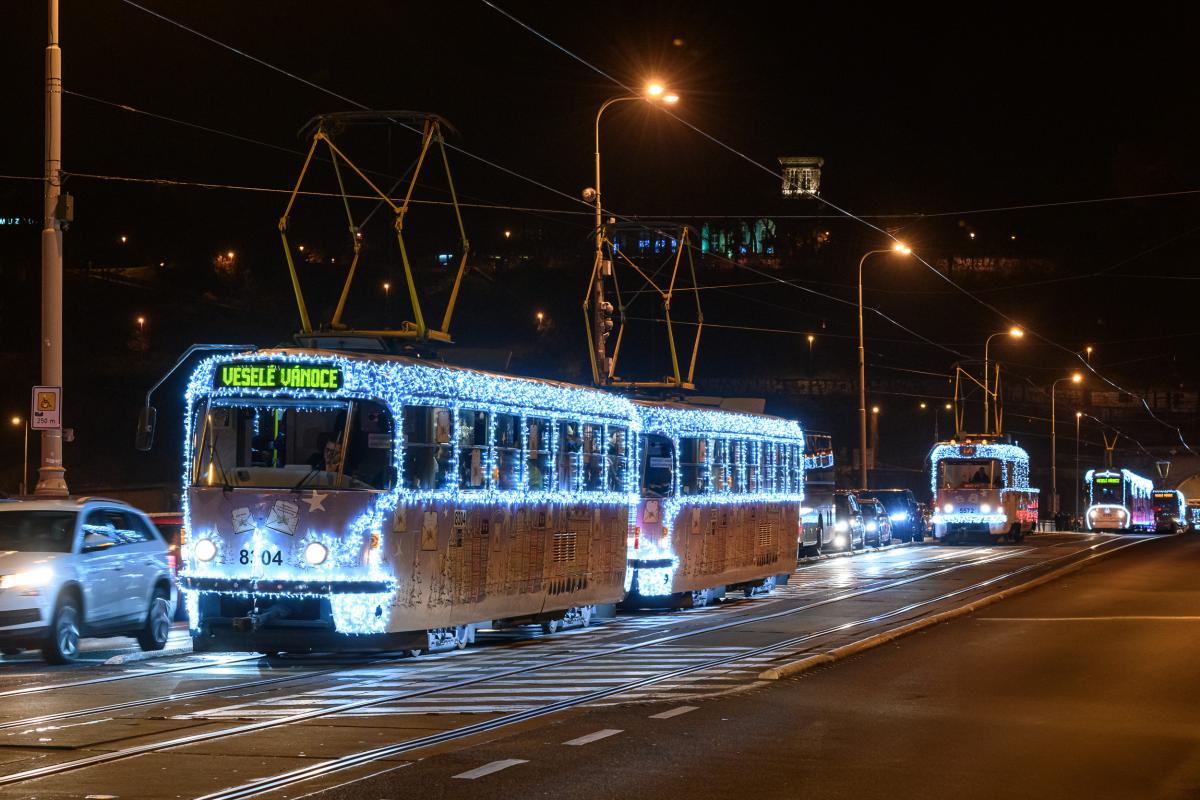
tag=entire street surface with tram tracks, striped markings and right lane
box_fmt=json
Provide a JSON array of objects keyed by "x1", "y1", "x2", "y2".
[{"x1": 0, "y1": 534, "x2": 1176, "y2": 800}]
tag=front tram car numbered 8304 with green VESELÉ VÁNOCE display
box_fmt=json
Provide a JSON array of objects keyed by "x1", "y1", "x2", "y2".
[{"x1": 180, "y1": 349, "x2": 640, "y2": 652}]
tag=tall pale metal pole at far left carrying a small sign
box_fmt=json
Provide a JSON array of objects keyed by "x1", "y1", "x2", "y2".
[{"x1": 34, "y1": 0, "x2": 67, "y2": 497}]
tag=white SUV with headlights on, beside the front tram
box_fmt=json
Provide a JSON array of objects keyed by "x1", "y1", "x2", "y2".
[{"x1": 0, "y1": 498, "x2": 175, "y2": 663}]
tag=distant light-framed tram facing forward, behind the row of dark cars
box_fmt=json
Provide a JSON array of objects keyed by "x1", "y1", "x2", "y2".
[{"x1": 929, "y1": 438, "x2": 1038, "y2": 542}]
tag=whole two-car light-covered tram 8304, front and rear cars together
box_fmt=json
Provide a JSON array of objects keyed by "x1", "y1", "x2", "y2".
[{"x1": 180, "y1": 348, "x2": 803, "y2": 652}]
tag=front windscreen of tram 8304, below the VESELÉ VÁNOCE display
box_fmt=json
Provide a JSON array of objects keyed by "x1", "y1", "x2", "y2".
[{"x1": 192, "y1": 398, "x2": 396, "y2": 489}]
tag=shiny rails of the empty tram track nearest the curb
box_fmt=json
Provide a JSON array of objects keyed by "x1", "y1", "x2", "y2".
[{"x1": 0, "y1": 540, "x2": 1099, "y2": 796}]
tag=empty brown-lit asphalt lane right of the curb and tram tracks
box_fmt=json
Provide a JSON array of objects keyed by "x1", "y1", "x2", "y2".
[{"x1": 321, "y1": 536, "x2": 1200, "y2": 800}]
